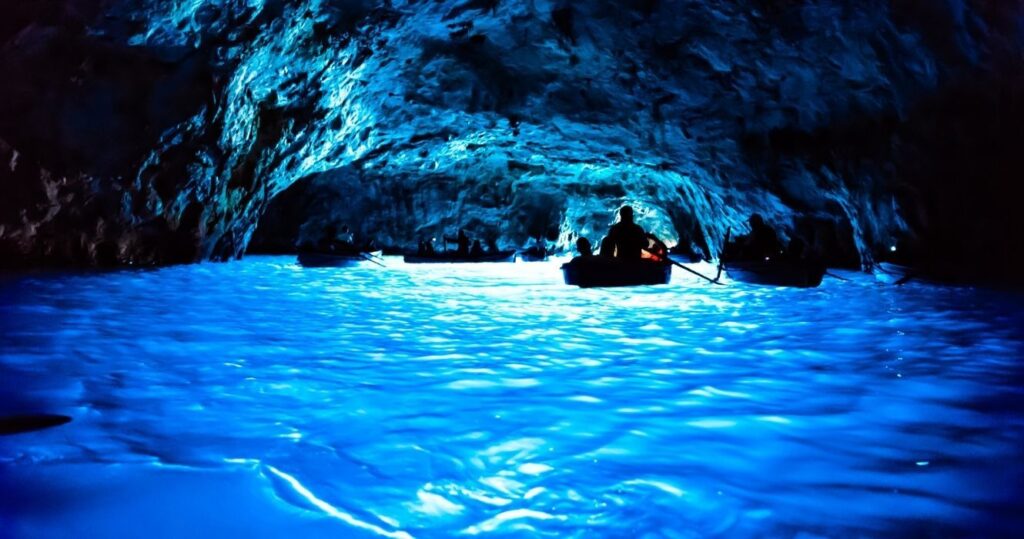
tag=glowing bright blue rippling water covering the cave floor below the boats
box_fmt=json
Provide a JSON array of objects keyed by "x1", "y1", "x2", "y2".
[{"x1": 0, "y1": 257, "x2": 1024, "y2": 537}]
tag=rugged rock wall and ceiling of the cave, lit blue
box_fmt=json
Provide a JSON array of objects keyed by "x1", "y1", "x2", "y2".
[{"x1": 0, "y1": 0, "x2": 1024, "y2": 278}]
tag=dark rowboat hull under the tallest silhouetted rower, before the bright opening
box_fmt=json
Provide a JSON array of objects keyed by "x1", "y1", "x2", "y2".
[{"x1": 562, "y1": 256, "x2": 672, "y2": 288}]
